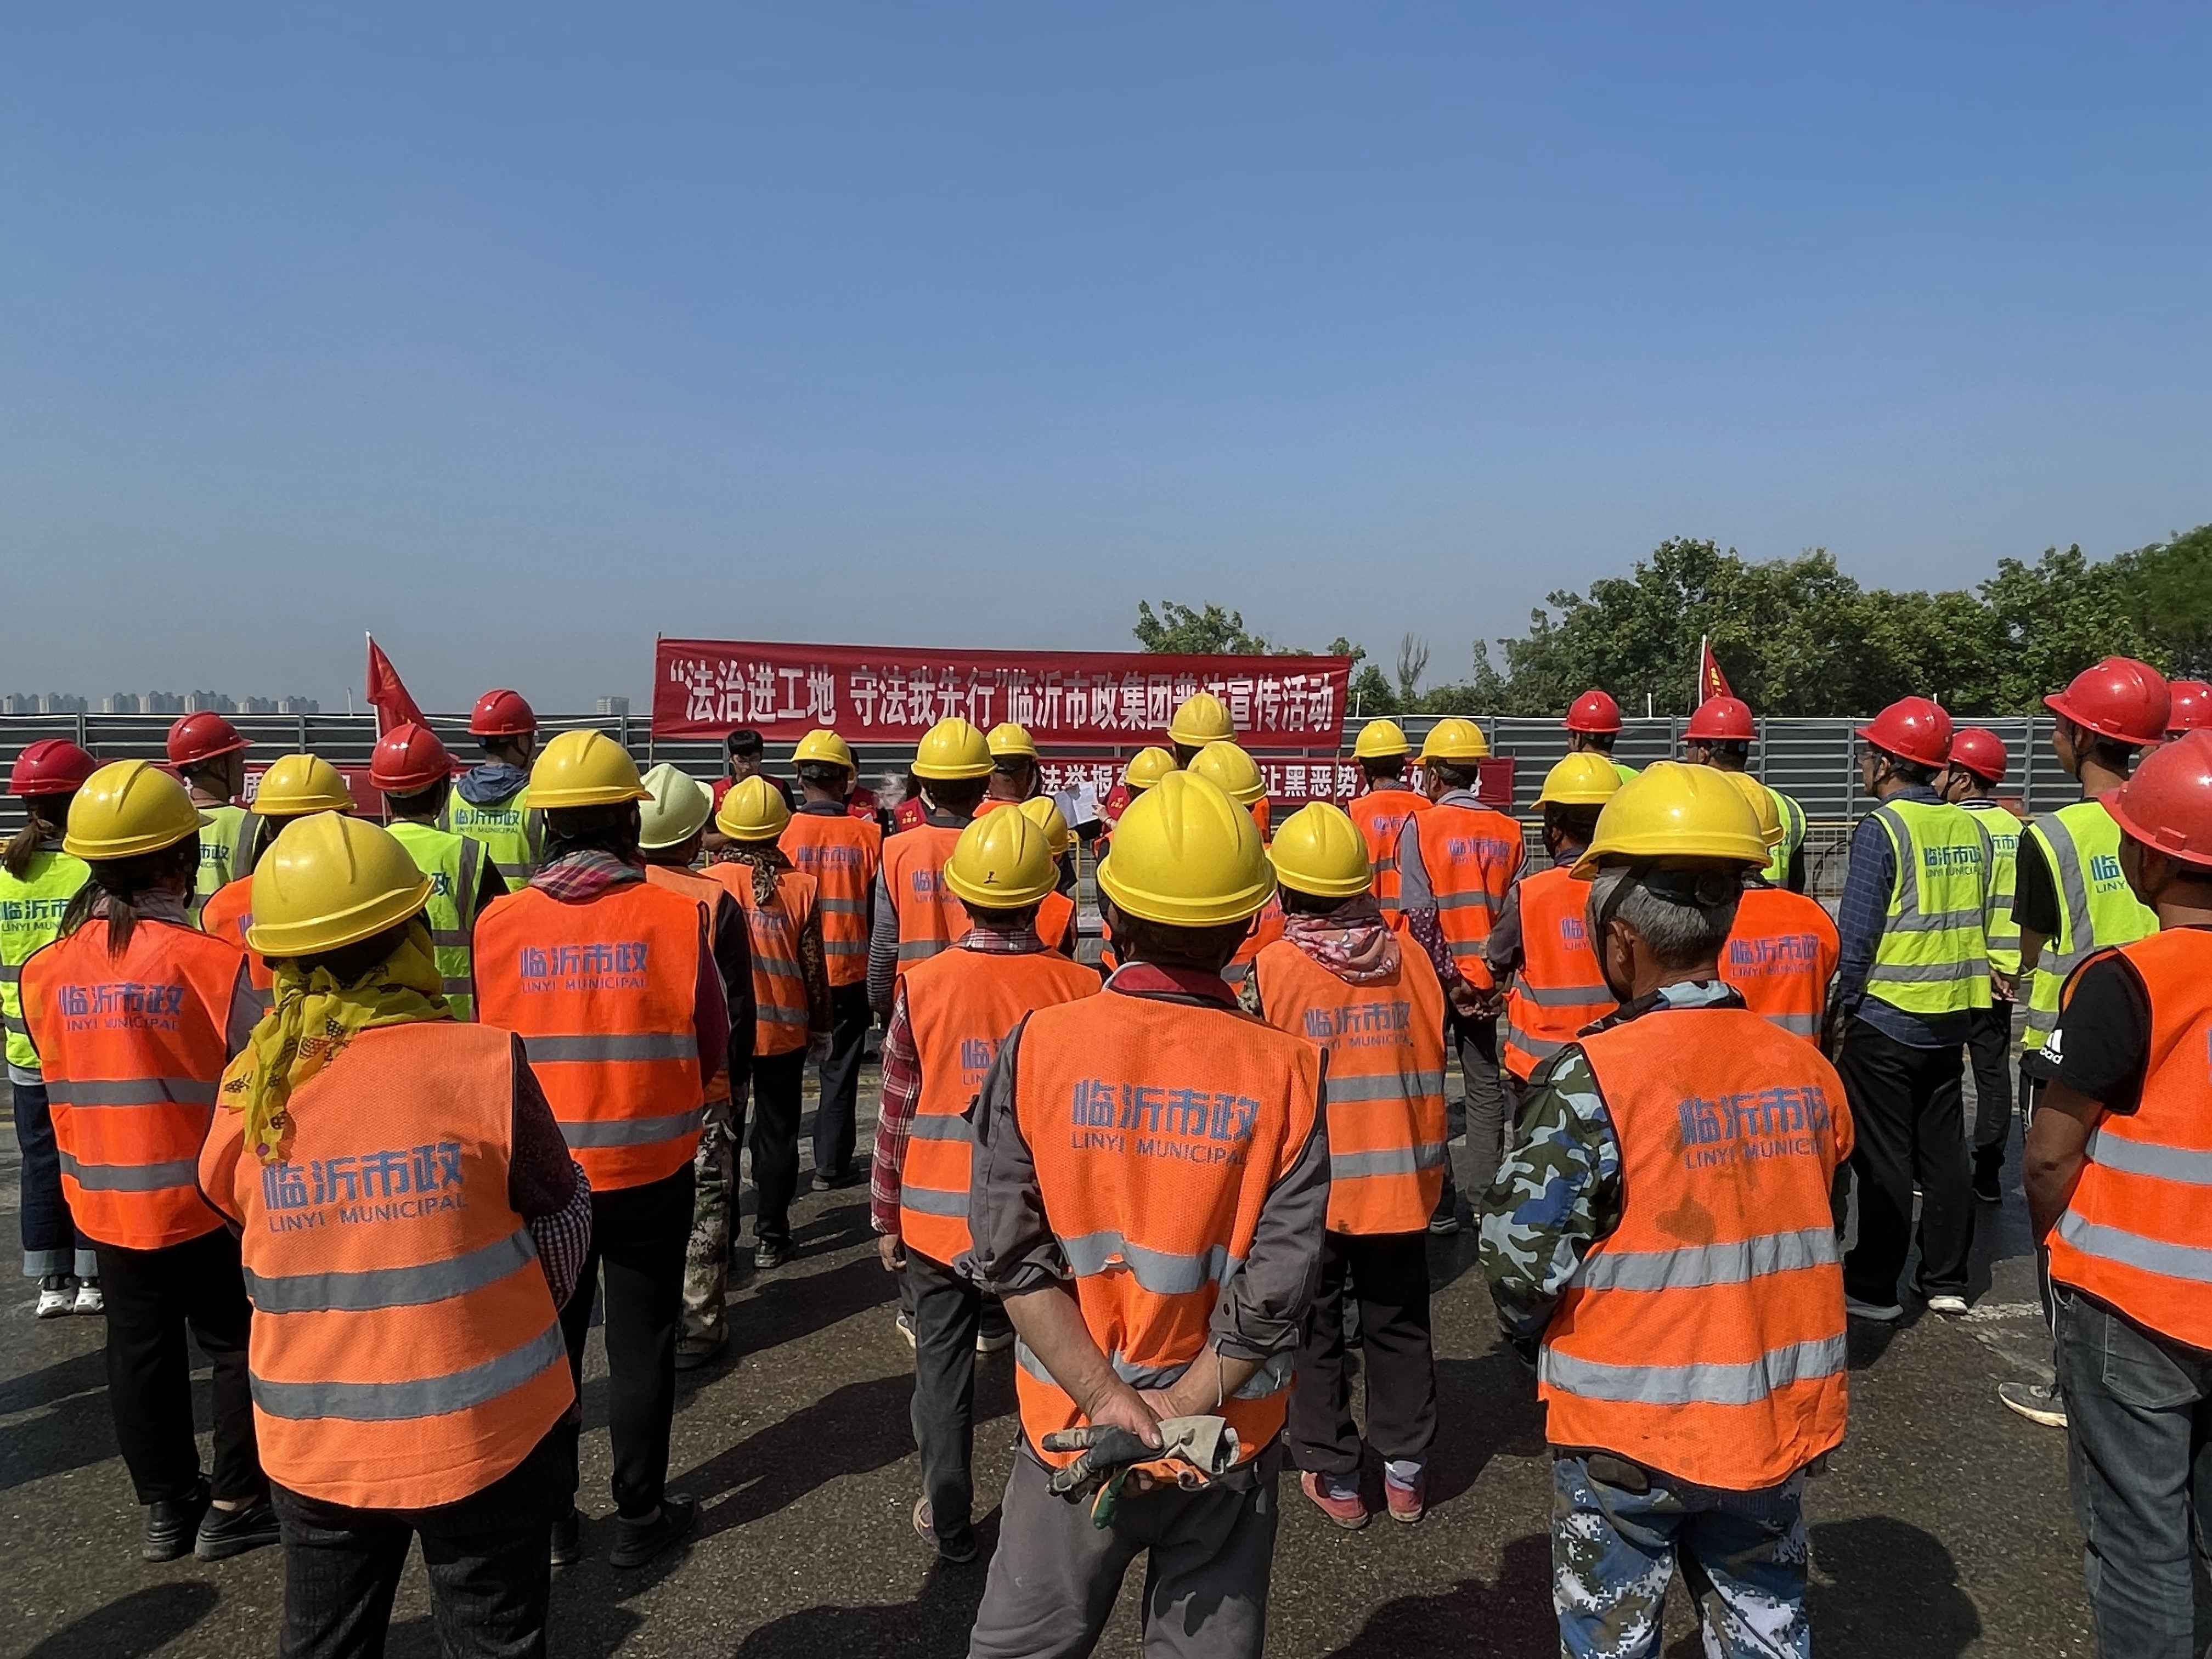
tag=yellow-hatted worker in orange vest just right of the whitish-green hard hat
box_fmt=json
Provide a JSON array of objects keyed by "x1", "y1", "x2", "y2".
[{"x1": 708, "y1": 776, "x2": 832, "y2": 1272}]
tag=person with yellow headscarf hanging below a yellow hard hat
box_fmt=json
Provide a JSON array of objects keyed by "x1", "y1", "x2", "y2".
[{"x1": 199, "y1": 814, "x2": 591, "y2": 1659}]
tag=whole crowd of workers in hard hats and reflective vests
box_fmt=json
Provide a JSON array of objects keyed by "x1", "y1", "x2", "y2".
[{"x1": 0, "y1": 659, "x2": 2212, "y2": 1659}]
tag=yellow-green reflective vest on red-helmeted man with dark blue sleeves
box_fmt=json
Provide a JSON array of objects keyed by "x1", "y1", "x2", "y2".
[{"x1": 1867, "y1": 801, "x2": 1991, "y2": 1015}]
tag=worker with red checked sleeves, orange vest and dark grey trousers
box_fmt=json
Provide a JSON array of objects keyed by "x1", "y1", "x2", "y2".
[{"x1": 870, "y1": 803, "x2": 1099, "y2": 1562}]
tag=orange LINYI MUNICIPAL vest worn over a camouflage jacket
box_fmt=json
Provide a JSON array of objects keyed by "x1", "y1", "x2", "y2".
[{"x1": 1537, "y1": 1009, "x2": 1852, "y2": 1491}]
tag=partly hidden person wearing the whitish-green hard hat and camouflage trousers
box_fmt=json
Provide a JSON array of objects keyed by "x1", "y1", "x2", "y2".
[{"x1": 637, "y1": 761, "x2": 754, "y2": 1372}]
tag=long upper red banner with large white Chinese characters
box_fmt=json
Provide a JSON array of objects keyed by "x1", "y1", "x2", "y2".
[{"x1": 652, "y1": 639, "x2": 1352, "y2": 754}]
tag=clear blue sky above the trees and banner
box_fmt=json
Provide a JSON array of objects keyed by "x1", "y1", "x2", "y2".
[{"x1": 0, "y1": 0, "x2": 2212, "y2": 708}]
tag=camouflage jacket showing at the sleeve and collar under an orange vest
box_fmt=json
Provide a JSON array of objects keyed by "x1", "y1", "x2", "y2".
[{"x1": 1480, "y1": 980, "x2": 1743, "y2": 1358}]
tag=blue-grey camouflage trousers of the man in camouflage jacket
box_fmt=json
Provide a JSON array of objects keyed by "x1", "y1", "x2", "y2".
[{"x1": 1550, "y1": 1451, "x2": 1812, "y2": 1659}]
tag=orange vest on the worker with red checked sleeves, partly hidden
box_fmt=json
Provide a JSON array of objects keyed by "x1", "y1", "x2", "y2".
[{"x1": 898, "y1": 949, "x2": 1099, "y2": 1263}]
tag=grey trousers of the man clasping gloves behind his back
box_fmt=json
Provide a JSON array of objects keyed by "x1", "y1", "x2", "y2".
[{"x1": 969, "y1": 1442, "x2": 1283, "y2": 1659}]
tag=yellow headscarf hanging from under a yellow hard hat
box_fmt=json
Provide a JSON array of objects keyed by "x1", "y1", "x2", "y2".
[{"x1": 221, "y1": 916, "x2": 452, "y2": 1164}]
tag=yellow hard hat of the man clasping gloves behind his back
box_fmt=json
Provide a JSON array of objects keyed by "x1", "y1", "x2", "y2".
[{"x1": 1097, "y1": 772, "x2": 1274, "y2": 927}]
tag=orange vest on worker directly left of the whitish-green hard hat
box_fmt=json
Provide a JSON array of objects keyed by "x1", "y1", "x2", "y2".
[{"x1": 476, "y1": 881, "x2": 708, "y2": 1192}]
